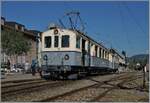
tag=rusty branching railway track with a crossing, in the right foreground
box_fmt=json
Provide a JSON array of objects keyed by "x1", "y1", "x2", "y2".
[{"x1": 38, "y1": 74, "x2": 142, "y2": 102}]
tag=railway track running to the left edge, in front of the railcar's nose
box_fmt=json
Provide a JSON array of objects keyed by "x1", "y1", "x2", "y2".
[{"x1": 1, "y1": 81, "x2": 62, "y2": 99}]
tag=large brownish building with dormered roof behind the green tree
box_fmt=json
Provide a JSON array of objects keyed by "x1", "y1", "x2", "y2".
[{"x1": 1, "y1": 17, "x2": 41, "y2": 64}]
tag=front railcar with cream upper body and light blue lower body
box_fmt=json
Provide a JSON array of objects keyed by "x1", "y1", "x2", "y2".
[{"x1": 41, "y1": 26, "x2": 124, "y2": 78}]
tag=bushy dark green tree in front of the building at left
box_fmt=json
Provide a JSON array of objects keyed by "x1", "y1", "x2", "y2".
[{"x1": 1, "y1": 30, "x2": 30, "y2": 56}]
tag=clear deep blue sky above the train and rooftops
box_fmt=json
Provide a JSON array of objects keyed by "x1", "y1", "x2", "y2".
[{"x1": 1, "y1": 1, "x2": 149, "y2": 56}]
